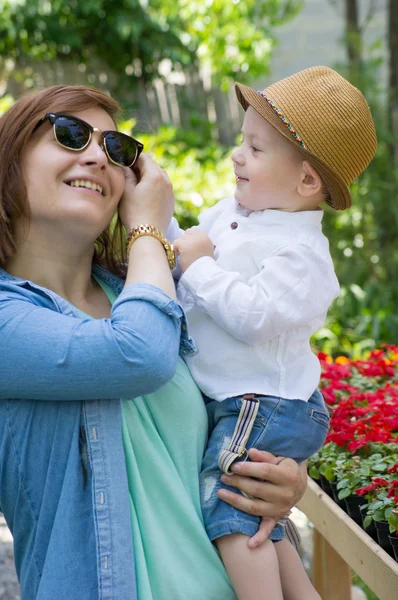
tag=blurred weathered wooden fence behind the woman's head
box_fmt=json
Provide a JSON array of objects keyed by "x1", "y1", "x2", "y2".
[{"x1": 0, "y1": 58, "x2": 242, "y2": 145}]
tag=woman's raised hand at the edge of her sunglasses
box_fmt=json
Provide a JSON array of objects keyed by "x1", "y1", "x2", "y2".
[{"x1": 119, "y1": 154, "x2": 174, "y2": 233}]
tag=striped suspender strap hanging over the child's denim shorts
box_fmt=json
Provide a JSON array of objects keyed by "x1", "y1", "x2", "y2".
[{"x1": 218, "y1": 394, "x2": 260, "y2": 473}]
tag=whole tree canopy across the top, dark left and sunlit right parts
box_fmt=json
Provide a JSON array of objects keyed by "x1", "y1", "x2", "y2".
[{"x1": 0, "y1": 0, "x2": 301, "y2": 94}]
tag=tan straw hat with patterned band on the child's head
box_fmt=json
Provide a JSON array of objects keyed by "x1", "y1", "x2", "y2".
[{"x1": 235, "y1": 67, "x2": 377, "y2": 210}]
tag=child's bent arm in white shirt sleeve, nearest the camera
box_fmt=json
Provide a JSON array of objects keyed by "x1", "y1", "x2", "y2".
[{"x1": 180, "y1": 244, "x2": 339, "y2": 345}]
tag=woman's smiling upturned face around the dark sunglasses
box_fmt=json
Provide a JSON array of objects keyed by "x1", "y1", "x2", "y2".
[{"x1": 21, "y1": 107, "x2": 125, "y2": 239}]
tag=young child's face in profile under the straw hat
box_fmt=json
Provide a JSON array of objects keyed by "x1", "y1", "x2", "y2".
[{"x1": 232, "y1": 106, "x2": 303, "y2": 211}]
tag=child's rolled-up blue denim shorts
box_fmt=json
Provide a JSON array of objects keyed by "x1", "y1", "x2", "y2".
[{"x1": 200, "y1": 390, "x2": 330, "y2": 542}]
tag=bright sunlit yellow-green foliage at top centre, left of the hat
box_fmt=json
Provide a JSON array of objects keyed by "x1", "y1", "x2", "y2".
[{"x1": 148, "y1": 0, "x2": 302, "y2": 89}]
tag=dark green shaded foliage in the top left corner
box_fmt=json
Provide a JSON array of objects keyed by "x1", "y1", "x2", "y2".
[{"x1": 0, "y1": 0, "x2": 193, "y2": 79}]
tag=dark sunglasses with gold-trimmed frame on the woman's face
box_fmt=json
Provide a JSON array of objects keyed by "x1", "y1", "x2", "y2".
[{"x1": 35, "y1": 113, "x2": 144, "y2": 167}]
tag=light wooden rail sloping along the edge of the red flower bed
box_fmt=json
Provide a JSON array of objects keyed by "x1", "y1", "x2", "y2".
[{"x1": 298, "y1": 479, "x2": 398, "y2": 600}]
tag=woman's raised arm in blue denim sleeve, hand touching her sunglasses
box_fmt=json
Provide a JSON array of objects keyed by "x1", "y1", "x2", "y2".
[{"x1": 0, "y1": 156, "x2": 183, "y2": 400}]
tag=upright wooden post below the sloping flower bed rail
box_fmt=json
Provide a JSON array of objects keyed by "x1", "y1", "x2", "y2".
[{"x1": 312, "y1": 529, "x2": 351, "y2": 600}]
